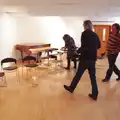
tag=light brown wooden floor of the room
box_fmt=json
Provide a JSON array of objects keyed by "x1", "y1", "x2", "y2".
[{"x1": 0, "y1": 60, "x2": 120, "y2": 120}]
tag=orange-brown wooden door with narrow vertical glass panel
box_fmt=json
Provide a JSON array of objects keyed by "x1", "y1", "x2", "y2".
[{"x1": 94, "y1": 25, "x2": 111, "y2": 57}]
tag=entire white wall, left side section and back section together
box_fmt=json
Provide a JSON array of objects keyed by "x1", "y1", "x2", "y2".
[{"x1": 0, "y1": 14, "x2": 83, "y2": 60}]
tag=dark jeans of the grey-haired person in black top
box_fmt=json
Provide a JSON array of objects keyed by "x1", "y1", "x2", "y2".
[{"x1": 70, "y1": 60, "x2": 98, "y2": 98}]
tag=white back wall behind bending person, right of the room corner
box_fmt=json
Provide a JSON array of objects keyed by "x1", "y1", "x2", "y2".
[{"x1": 17, "y1": 17, "x2": 82, "y2": 47}]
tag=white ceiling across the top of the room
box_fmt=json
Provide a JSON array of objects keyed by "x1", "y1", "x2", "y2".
[{"x1": 0, "y1": 0, "x2": 120, "y2": 21}]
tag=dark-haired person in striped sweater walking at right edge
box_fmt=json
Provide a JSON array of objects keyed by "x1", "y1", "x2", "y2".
[{"x1": 102, "y1": 23, "x2": 120, "y2": 82}]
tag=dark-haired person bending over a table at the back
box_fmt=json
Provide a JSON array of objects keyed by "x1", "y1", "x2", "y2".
[{"x1": 63, "y1": 34, "x2": 76, "y2": 70}]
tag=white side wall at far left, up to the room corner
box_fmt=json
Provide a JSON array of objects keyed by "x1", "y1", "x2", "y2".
[{"x1": 0, "y1": 14, "x2": 17, "y2": 60}]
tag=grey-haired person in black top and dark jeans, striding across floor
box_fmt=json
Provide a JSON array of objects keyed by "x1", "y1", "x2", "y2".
[{"x1": 64, "y1": 20, "x2": 100, "y2": 100}]
